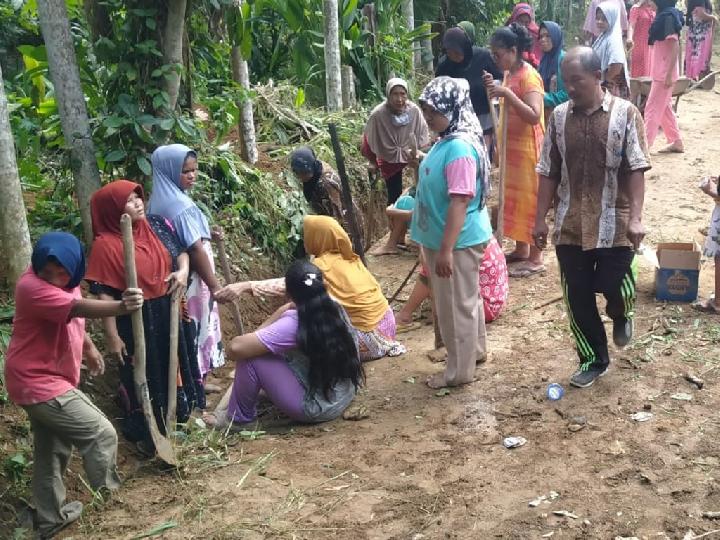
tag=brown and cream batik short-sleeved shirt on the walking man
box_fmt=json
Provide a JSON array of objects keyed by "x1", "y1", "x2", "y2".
[{"x1": 537, "y1": 92, "x2": 650, "y2": 250}]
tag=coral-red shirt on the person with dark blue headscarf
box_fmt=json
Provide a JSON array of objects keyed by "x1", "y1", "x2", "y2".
[{"x1": 5, "y1": 268, "x2": 85, "y2": 405}]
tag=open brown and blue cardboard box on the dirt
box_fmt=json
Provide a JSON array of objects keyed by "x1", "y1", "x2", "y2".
[{"x1": 655, "y1": 242, "x2": 700, "y2": 302}]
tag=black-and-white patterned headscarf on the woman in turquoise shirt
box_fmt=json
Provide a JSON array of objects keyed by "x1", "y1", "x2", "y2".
[{"x1": 418, "y1": 76, "x2": 490, "y2": 200}]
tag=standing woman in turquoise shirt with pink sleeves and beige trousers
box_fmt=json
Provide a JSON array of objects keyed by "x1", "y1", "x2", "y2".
[{"x1": 410, "y1": 77, "x2": 492, "y2": 388}]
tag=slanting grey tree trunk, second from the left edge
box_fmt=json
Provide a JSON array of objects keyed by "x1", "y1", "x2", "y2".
[{"x1": 37, "y1": 0, "x2": 100, "y2": 244}]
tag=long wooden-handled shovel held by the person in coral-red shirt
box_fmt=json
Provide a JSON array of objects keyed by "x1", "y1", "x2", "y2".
[{"x1": 120, "y1": 214, "x2": 177, "y2": 465}]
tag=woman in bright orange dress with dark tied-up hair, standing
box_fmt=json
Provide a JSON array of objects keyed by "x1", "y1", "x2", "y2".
[{"x1": 485, "y1": 24, "x2": 545, "y2": 277}]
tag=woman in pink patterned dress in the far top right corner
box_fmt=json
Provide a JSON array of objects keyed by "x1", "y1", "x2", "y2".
[{"x1": 685, "y1": 0, "x2": 717, "y2": 80}]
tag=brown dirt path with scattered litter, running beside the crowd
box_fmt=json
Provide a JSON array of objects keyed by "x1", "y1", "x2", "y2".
[{"x1": 62, "y1": 86, "x2": 720, "y2": 540}]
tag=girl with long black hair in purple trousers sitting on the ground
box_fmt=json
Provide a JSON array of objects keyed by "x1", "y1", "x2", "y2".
[{"x1": 204, "y1": 260, "x2": 365, "y2": 430}]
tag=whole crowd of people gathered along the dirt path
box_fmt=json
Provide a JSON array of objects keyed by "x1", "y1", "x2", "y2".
[{"x1": 5, "y1": 0, "x2": 720, "y2": 537}]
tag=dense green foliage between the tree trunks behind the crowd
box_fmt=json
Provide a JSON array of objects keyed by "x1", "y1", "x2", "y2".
[{"x1": 0, "y1": 0, "x2": 524, "y2": 259}]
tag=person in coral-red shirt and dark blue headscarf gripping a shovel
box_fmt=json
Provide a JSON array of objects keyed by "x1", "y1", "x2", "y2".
[{"x1": 5, "y1": 232, "x2": 143, "y2": 538}]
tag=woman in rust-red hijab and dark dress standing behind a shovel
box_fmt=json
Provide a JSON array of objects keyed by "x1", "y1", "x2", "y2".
[{"x1": 85, "y1": 180, "x2": 205, "y2": 450}]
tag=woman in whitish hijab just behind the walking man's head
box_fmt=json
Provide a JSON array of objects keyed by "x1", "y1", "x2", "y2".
[{"x1": 593, "y1": 1, "x2": 630, "y2": 98}]
